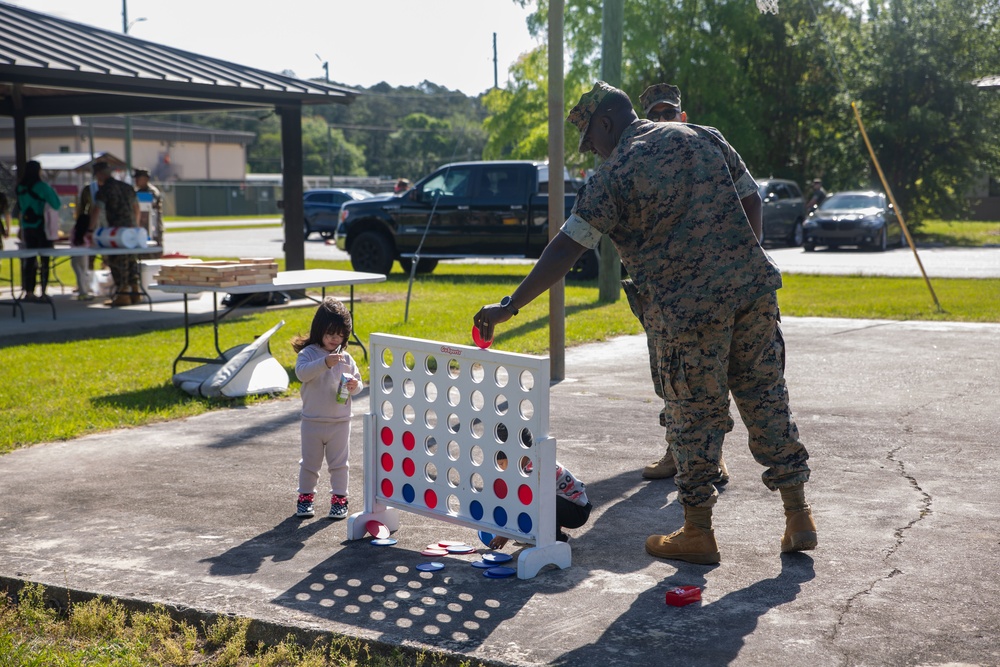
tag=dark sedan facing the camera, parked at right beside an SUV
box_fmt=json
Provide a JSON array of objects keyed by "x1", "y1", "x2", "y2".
[{"x1": 802, "y1": 190, "x2": 906, "y2": 252}]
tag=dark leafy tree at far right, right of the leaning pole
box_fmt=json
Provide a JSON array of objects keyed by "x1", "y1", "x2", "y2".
[{"x1": 851, "y1": 0, "x2": 1000, "y2": 222}]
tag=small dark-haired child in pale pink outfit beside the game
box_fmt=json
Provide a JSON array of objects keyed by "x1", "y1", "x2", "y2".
[{"x1": 292, "y1": 298, "x2": 364, "y2": 519}]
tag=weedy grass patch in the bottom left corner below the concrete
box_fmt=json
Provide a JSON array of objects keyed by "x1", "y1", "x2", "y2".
[{"x1": 0, "y1": 577, "x2": 500, "y2": 667}]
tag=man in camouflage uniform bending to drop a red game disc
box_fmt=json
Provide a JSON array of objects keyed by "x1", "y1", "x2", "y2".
[{"x1": 473, "y1": 81, "x2": 817, "y2": 563}]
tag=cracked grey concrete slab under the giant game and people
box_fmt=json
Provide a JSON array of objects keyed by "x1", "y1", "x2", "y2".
[{"x1": 0, "y1": 318, "x2": 1000, "y2": 667}]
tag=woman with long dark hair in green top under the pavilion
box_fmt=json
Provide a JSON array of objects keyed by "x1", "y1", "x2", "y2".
[{"x1": 17, "y1": 160, "x2": 61, "y2": 301}]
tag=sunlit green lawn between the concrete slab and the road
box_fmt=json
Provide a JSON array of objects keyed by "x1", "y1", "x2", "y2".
[{"x1": 0, "y1": 262, "x2": 1000, "y2": 454}]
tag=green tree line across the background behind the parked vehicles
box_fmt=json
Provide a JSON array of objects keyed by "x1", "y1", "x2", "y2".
[{"x1": 160, "y1": 0, "x2": 1000, "y2": 223}]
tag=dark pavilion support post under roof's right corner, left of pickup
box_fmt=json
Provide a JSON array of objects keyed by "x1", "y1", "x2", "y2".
[{"x1": 277, "y1": 104, "x2": 306, "y2": 271}]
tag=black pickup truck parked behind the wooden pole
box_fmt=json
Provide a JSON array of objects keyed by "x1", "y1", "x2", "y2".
[{"x1": 336, "y1": 161, "x2": 598, "y2": 280}]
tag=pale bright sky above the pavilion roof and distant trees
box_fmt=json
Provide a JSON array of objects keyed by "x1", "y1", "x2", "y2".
[{"x1": 11, "y1": 0, "x2": 538, "y2": 95}]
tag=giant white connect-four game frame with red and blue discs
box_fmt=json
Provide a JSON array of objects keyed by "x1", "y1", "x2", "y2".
[{"x1": 347, "y1": 334, "x2": 572, "y2": 579}]
